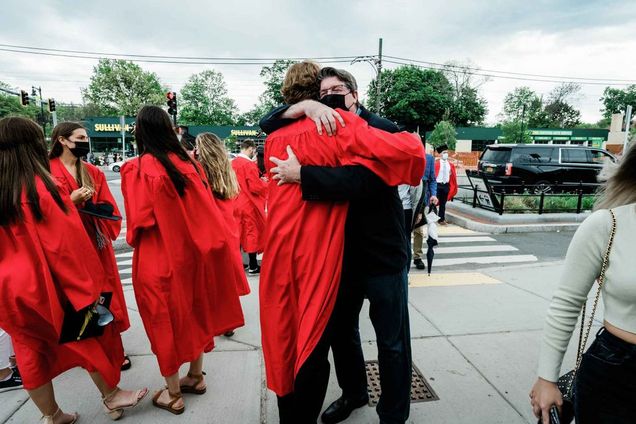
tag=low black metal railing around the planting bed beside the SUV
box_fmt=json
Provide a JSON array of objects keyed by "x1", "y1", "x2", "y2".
[{"x1": 458, "y1": 170, "x2": 600, "y2": 215}]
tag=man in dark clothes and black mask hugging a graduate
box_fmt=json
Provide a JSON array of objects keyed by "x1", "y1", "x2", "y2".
[{"x1": 260, "y1": 68, "x2": 414, "y2": 424}]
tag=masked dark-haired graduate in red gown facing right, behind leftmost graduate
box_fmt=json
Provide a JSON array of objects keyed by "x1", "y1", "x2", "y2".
[{"x1": 49, "y1": 122, "x2": 130, "y2": 372}]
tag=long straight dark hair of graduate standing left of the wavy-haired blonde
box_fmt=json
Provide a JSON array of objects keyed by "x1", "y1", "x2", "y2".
[{"x1": 135, "y1": 106, "x2": 199, "y2": 197}]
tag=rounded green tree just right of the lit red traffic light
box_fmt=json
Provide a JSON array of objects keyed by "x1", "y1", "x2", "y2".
[{"x1": 179, "y1": 69, "x2": 238, "y2": 125}]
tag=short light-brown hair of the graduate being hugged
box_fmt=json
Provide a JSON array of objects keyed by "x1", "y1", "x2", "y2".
[{"x1": 280, "y1": 60, "x2": 320, "y2": 105}]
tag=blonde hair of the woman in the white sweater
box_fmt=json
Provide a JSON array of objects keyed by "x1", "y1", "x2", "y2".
[{"x1": 594, "y1": 143, "x2": 636, "y2": 210}]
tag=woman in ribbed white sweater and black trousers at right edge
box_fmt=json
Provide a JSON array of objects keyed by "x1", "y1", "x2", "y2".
[{"x1": 530, "y1": 143, "x2": 636, "y2": 424}]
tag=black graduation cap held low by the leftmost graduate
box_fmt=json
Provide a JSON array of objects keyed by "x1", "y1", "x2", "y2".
[{"x1": 59, "y1": 292, "x2": 115, "y2": 344}]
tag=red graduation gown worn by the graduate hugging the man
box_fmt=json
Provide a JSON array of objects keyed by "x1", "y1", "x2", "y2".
[{"x1": 260, "y1": 112, "x2": 425, "y2": 396}]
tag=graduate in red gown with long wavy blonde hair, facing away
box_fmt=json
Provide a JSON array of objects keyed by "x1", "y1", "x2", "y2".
[{"x1": 194, "y1": 133, "x2": 250, "y2": 298}]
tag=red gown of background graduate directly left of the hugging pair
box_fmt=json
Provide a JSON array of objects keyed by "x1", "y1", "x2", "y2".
[{"x1": 232, "y1": 156, "x2": 267, "y2": 253}]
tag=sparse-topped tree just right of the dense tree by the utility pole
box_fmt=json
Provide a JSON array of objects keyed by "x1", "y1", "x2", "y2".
[{"x1": 442, "y1": 62, "x2": 490, "y2": 127}]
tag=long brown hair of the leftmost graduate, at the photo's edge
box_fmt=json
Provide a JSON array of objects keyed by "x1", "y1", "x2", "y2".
[{"x1": 0, "y1": 117, "x2": 67, "y2": 225}]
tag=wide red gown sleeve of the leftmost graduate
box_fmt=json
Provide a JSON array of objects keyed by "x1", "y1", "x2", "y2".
[{"x1": 35, "y1": 184, "x2": 104, "y2": 310}]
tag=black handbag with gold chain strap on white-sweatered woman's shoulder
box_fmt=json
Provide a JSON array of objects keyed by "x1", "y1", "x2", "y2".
[{"x1": 539, "y1": 209, "x2": 616, "y2": 424}]
